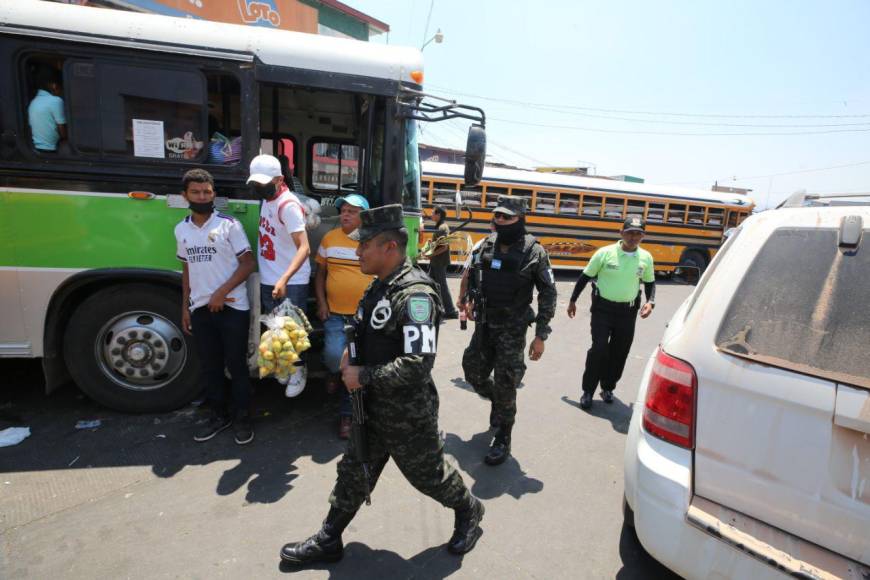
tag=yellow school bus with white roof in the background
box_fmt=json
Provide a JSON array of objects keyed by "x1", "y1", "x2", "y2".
[{"x1": 421, "y1": 162, "x2": 754, "y2": 272}]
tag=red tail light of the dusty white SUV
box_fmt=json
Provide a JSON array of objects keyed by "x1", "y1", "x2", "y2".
[{"x1": 643, "y1": 348, "x2": 698, "y2": 449}]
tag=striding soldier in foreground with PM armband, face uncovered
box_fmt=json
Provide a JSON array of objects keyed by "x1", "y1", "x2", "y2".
[{"x1": 281, "y1": 205, "x2": 484, "y2": 565}]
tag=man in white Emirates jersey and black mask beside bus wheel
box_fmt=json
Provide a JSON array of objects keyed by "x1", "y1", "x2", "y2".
[{"x1": 175, "y1": 169, "x2": 254, "y2": 445}]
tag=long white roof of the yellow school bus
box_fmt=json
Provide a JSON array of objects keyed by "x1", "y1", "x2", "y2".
[{"x1": 422, "y1": 161, "x2": 754, "y2": 208}]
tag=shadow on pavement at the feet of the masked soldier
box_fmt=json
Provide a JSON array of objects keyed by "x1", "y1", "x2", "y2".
[{"x1": 445, "y1": 431, "x2": 544, "y2": 499}]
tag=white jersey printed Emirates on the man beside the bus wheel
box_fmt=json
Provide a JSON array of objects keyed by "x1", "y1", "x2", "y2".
[{"x1": 175, "y1": 212, "x2": 251, "y2": 311}]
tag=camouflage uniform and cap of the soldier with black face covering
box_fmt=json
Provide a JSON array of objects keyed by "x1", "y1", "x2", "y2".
[{"x1": 462, "y1": 196, "x2": 556, "y2": 460}]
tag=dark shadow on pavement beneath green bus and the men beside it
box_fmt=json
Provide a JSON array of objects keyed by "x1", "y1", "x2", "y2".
[{"x1": 0, "y1": 361, "x2": 346, "y2": 503}]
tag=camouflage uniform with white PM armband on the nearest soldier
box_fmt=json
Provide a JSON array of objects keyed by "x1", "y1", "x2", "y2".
[{"x1": 329, "y1": 211, "x2": 471, "y2": 512}]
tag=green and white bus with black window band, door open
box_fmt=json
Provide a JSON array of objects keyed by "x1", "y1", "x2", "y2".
[{"x1": 0, "y1": 1, "x2": 485, "y2": 411}]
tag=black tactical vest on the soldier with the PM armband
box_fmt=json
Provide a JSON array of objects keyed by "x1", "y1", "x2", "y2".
[{"x1": 356, "y1": 267, "x2": 442, "y2": 365}]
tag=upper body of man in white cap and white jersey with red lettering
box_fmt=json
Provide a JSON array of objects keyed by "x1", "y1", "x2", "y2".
[{"x1": 248, "y1": 155, "x2": 311, "y2": 312}]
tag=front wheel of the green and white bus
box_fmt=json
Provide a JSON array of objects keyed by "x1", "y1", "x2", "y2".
[{"x1": 64, "y1": 284, "x2": 199, "y2": 413}]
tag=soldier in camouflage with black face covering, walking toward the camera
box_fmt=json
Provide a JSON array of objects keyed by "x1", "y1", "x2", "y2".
[{"x1": 462, "y1": 195, "x2": 556, "y2": 465}]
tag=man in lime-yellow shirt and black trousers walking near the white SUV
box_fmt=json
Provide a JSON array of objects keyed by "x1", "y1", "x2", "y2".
[{"x1": 568, "y1": 215, "x2": 656, "y2": 409}]
